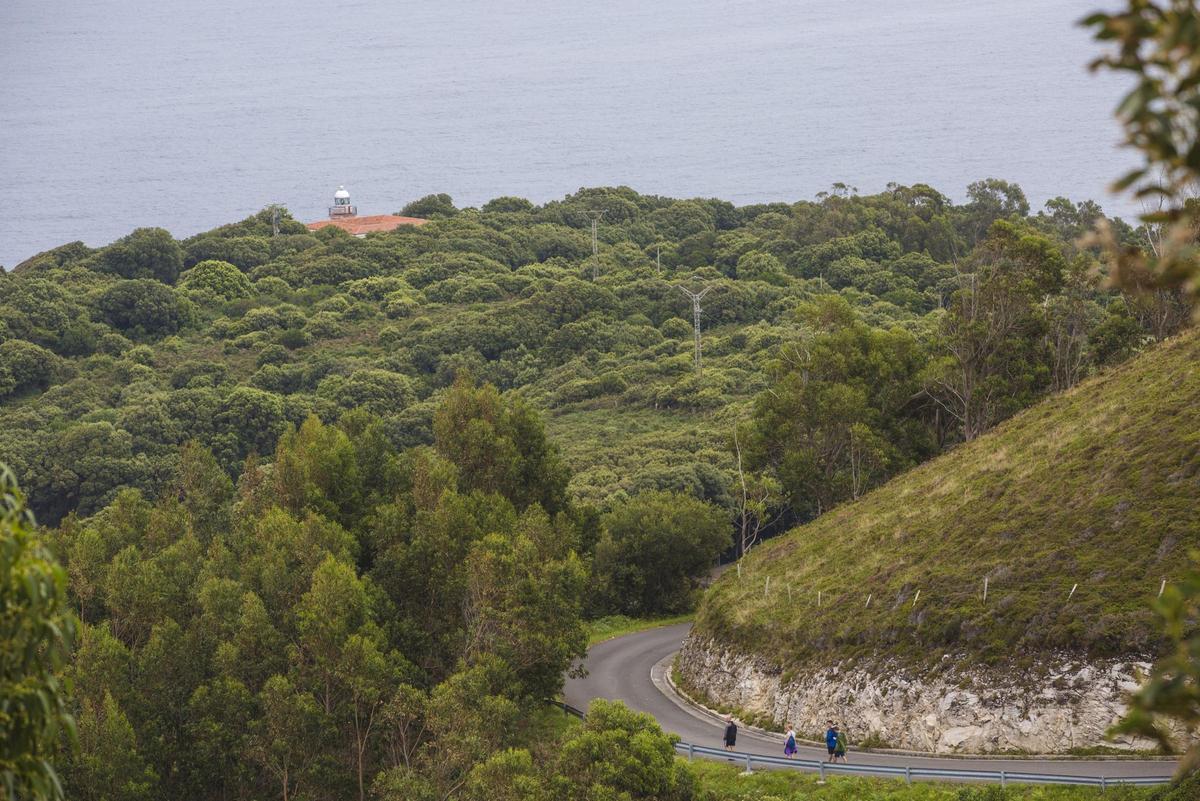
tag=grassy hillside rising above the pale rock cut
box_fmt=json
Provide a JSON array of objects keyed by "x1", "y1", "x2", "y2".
[{"x1": 697, "y1": 332, "x2": 1200, "y2": 669}]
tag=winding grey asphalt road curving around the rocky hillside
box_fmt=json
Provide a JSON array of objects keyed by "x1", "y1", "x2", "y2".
[{"x1": 564, "y1": 624, "x2": 1175, "y2": 778}]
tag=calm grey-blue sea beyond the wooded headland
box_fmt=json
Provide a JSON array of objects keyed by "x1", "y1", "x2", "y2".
[{"x1": 0, "y1": 0, "x2": 1134, "y2": 266}]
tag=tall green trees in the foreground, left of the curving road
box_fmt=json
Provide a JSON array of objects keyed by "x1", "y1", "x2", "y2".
[{"x1": 0, "y1": 417, "x2": 698, "y2": 801}]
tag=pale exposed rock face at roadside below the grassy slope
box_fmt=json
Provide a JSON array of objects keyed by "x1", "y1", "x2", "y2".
[{"x1": 677, "y1": 636, "x2": 1176, "y2": 754}]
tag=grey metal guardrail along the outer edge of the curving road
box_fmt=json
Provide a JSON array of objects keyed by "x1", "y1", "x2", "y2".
[{"x1": 548, "y1": 700, "x2": 1171, "y2": 790}]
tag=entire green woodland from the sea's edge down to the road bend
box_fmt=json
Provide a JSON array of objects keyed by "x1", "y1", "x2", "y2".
[{"x1": 0, "y1": 180, "x2": 1189, "y2": 801}]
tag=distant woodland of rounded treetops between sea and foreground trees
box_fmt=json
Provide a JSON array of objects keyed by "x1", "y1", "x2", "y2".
[{"x1": 0, "y1": 180, "x2": 1187, "y2": 531}]
